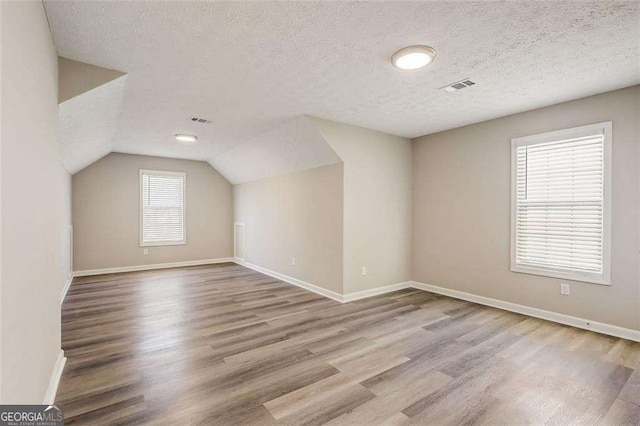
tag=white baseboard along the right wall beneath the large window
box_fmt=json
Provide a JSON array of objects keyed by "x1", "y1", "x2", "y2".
[{"x1": 411, "y1": 281, "x2": 640, "y2": 342}]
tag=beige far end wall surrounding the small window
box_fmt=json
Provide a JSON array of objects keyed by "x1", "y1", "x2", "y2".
[{"x1": 73, "y1": 153, "x2": 233, "y2": 271}]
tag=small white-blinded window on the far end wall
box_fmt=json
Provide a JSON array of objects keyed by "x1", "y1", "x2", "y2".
[{"x1": 140, "y1": 170, "x2": 186, "y2": 246}]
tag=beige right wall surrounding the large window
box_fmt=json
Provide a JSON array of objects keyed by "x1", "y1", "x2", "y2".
[{"x1": 413, "y1": 86, "x2": 640, "y2": 329}]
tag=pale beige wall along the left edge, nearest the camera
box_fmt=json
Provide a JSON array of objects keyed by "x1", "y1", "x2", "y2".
[{"x1": 0, "y1": 1, "x2": 69, "y2": 404}]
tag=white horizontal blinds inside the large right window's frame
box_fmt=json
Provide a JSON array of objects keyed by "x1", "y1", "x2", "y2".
[{"x1": 514, "y1": 134, "x2": 604, "y2": 274}]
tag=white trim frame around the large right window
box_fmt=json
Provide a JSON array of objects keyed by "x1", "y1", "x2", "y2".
[{"x1": 511, "y1": 121, "x2": 613, "y2": 285}]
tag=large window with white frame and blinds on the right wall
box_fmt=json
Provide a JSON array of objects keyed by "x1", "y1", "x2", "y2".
[{"x1": 511, "y1": 122, "x2": 611, "y2": 284}]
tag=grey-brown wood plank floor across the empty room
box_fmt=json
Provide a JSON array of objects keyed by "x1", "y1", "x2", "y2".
[{"x1": 56, "y1": 264, "x2": 640, "y2": 426}]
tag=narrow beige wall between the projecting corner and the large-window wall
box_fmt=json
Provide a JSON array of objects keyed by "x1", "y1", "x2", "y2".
[{"x1": 310, "y1": 117, "x2": 412, "y2": 294}]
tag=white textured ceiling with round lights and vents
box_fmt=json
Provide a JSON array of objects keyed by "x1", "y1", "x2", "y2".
[{"x1": 45, "y1": 1, "x2": 640, "y2": 173}]
